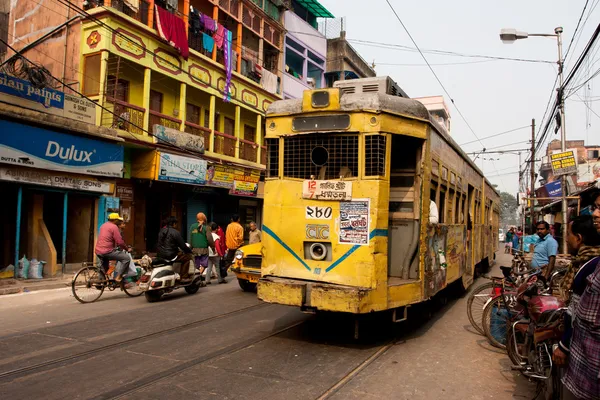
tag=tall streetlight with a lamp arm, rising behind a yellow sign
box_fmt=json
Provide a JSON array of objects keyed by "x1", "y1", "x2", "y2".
[{"x1": 500, "y1": 26, "x2": 568, "y2": 252}]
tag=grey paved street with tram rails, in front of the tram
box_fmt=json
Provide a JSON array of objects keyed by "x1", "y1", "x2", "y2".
[{"x1": 0, "y1": 252, "x2": 534, "y2": 400}]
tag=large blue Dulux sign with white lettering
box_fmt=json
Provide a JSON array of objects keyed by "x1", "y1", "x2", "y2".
[{"x1": 0, "y1": 121, "x2": 123, "y2": 177}]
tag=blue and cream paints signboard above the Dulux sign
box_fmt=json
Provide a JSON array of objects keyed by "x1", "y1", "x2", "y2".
[{"x1": 0, "y1": 73, "x2": 96, "y2": 125}]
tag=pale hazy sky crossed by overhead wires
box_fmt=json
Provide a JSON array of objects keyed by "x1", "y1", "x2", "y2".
[{"x1": 320, "y1": 0, "x2": 600, "y2": 193}]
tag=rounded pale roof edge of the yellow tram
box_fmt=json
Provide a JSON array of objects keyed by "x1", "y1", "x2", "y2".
[{"x1": 267, "y1": 93, "x2": 500, "y2": 195}]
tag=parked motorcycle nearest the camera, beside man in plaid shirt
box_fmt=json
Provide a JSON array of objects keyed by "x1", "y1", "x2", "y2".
[{"x1": 506, "y1": 276, "x2": 567, "y2": 395}]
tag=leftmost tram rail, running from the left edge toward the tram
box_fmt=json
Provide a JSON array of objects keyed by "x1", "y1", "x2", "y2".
[{"x1": 0, "y1": 303, "x2": 273, "y2": 382}]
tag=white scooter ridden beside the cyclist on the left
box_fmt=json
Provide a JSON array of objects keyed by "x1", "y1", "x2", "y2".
[{"x1": 139, "y1": 245, "x2": 202, "y2": 303}]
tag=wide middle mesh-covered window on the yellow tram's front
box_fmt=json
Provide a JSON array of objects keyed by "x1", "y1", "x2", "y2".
[{"x1": 283, "y1": 133, "x2": 358, "y2": 180}]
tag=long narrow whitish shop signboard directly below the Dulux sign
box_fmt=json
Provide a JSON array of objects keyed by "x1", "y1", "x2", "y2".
[{"x1": 0, "y1": 167, "x2": 112, "y2": 193}]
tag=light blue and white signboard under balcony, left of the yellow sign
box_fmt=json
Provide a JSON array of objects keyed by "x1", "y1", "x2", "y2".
[{"x1": 157, "y1": 153, "x2": 206, "y2": 185}]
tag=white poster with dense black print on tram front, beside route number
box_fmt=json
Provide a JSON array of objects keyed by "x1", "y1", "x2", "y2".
[{"x1": 339, "y1": 199, "x2": 369, "y2": 246}]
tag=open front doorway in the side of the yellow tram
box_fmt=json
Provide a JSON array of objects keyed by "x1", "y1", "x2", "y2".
[{"x1": 388, "y1": 135, "x2": 425, "y2": 284}]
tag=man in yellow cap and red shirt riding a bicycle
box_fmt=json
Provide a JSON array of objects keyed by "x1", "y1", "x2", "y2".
[{"x1": 96, "y1": 213, "x2": 131, "y2": 282}]
